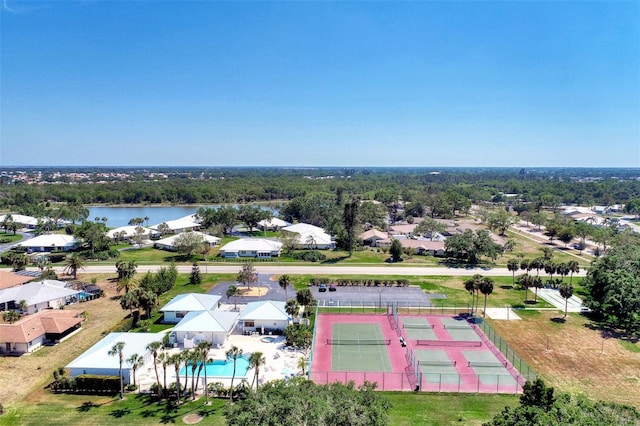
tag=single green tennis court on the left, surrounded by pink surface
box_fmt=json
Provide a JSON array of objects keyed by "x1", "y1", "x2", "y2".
[{"x1": 331, "y1": 323, "x2": 393, "y2": 372}]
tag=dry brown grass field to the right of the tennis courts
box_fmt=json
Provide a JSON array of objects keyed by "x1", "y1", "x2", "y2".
[{"x1": 489, "y1": 312, "x2": 640, "y2": 407}]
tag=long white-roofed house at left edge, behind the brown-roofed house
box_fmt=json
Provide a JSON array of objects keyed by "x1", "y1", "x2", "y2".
[{"x1": 0, "y1": 280, "x2": 80, "y2": 314}]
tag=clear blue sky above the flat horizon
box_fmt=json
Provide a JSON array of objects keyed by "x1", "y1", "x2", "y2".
[{"x1": 0, "y1": 0, "x2": 640, "y2": 167}]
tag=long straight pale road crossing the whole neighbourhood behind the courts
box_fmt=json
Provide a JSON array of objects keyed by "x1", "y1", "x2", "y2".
[{"x1": 13, "y1": 264, "x2": 585, "y2": 277}]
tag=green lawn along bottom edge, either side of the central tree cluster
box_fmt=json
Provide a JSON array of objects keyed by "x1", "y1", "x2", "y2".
[{"x1": 0, "y1": 392, "x2": 518, "y2": 426}]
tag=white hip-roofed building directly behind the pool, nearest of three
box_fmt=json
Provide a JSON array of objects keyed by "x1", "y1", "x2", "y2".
[{"x1": 170, "y1": 311, "x2": 239, "y2": 349}]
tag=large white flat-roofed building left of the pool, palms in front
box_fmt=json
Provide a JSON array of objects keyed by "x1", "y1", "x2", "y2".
[{"x1": 66, "y1": 332, "x2": 165, "y2": 384}]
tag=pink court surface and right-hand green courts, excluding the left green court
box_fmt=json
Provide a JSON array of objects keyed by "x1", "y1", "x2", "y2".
[{"x1": 310, "y1": 313, "x2": 525, "y2": 393}]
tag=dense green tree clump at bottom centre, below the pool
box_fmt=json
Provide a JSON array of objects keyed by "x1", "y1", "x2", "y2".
[{"x1": 225, "y1": 378, "x2": 390, "y2": 426}]
